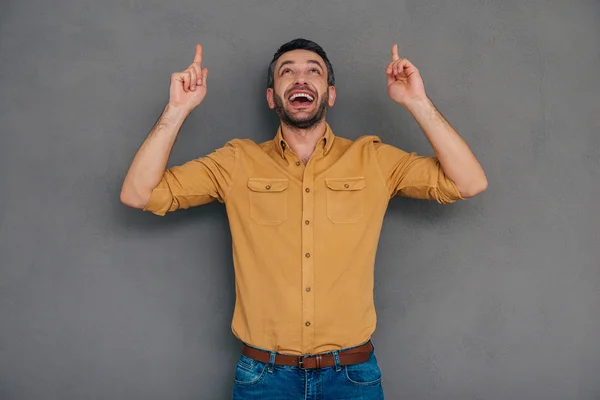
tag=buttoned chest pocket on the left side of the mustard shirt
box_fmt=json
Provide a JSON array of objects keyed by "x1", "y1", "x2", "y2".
[{"x1": 248, "y1": 178, "x2": 288, "y2": 225}]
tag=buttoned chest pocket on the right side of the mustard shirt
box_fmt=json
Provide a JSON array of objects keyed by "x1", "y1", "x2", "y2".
[{"x1": 325, "y1": 177, "x2": 367, "y2": 224}]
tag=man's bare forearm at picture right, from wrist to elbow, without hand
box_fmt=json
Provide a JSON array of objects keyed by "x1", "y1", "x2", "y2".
[{"x1": 406, "y1": 98, "x2": 487, "y2": 198}]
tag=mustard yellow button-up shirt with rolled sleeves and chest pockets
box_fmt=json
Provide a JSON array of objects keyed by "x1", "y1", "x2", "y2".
[{"x1": 144, "y1": 125, "x2": 463, "y2": 354}]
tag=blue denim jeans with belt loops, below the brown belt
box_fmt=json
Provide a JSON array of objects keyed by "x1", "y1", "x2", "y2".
[{"x1": 232, "y1": 340, "x2": 383, "y2": 400}]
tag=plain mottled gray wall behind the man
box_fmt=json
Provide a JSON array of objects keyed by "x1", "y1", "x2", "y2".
[{"x1": 0, "y1": 0, "x2": 600, "y2": 400}]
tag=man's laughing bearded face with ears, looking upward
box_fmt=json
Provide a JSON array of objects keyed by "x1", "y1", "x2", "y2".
[{"x1": 267, "y1": 50, "x2": 335, "y2": 129}]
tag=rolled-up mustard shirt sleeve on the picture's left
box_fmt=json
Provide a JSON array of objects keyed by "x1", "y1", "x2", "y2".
[{"x1": 143, "y1": 141, "x2": 237, "y2": 216}]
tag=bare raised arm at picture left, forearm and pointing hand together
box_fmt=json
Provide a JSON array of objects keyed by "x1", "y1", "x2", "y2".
[{"x1": 121, "y1": 44, "x2": 208, "y2": 209}]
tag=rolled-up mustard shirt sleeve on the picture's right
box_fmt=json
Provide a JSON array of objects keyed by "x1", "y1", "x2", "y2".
[{"x1": 374, "y1": 141, "x2": 464, "y2": 204}]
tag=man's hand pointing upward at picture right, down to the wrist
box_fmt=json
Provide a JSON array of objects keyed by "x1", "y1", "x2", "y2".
[{"x1": 385, "y1": 44, "x2": 427, "y2": 106}]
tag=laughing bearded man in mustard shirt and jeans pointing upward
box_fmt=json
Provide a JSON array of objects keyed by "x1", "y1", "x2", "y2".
[{"x1": 121, "y1": 39, "x2": 487, "y2": 400}]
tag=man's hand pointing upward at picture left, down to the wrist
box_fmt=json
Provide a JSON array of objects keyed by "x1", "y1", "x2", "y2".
[{"x1": 169, "y1": 44, "x2": 208, "y2": 112}]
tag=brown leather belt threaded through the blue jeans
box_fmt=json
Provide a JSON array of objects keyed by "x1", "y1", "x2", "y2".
[{"x1": 242, "y1": 341, "x2": 373, "y2": 369}]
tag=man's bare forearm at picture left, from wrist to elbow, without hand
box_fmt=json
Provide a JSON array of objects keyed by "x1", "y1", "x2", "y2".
[{"x1": 121, "y1": 105, "x2": 189, "y2": 208}]
